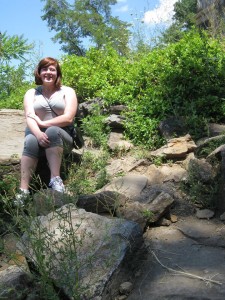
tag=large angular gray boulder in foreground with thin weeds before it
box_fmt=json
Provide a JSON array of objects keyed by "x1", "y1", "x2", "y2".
[{"x1": 20, "y1": 204, "x2": 143, "y2": 299}]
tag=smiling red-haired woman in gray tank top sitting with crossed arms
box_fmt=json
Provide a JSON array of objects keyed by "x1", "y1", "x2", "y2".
[{"x1": 16, "y1": 57, "x2": 78, "y2": 204}]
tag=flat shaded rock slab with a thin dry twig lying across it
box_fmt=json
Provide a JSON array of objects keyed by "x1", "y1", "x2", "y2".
[{"x1": 127, "y1": 218, "x2": 225, "y2": 300}]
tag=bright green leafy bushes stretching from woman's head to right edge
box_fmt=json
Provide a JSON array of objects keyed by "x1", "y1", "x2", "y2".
[{"x1": 60, "y1": 29, "x2": 225, "y2": 148}]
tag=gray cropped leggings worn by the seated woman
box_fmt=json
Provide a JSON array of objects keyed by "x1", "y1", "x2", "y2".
[{"x1": 22, "y1": 126, "x2": 73, "y2": 158}]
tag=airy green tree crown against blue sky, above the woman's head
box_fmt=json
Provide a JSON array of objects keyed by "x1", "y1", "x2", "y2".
[{"x1": 42, "y1": 0, "x2": 129, "y2": 56}]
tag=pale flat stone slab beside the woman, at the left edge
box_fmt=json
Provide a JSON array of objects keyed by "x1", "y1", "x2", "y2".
[{"x1": 0, "y1": 109, "x2": 26, "y2": 161}]
